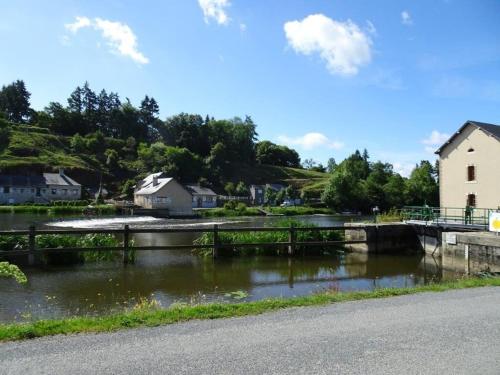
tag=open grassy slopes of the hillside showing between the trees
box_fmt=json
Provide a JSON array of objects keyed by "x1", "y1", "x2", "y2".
[{"x1": 0, "y1": 125, "x2": 329, "y2": 195}]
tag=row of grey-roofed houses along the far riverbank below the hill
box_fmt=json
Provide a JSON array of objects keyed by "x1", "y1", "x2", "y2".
[{"x1": 0, "y1": 169, "x2": 301, "y2": 216}]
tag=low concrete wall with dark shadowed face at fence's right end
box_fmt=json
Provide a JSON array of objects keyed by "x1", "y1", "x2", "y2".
[{"x1": 345, "y1": 223, "x2": 422, "y2": 253}]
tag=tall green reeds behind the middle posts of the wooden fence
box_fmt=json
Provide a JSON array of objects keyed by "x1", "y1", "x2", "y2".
[{"x1": 193, "y1": 220, "x2": 343, "y2": 256}]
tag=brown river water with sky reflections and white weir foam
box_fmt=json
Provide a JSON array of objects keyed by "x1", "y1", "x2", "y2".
[{"x1": 0, "y1": 214, "x2": 441, "y2": 322}]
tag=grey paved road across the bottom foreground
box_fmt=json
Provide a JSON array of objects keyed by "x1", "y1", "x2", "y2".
[{"x1": 0, "y1": 288, "x2": 500, "y2": 375}]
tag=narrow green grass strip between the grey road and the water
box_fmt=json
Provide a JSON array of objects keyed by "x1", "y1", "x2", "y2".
[{"x1": 0, "y1": 278, "x2": 500, "y2": 341}]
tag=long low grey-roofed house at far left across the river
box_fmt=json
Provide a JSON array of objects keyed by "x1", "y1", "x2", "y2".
[{"x1": 0, "y1": 169, "x2": 82, "y2": 204}]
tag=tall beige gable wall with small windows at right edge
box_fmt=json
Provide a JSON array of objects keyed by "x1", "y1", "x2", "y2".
[{"x1": 439, "y1": 124, "x2": 500, "y2": 209}]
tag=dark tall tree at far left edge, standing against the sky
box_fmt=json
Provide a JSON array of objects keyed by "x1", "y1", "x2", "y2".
[{"x1": 0, "y1": 80, "x2": 31, "y2": 123}]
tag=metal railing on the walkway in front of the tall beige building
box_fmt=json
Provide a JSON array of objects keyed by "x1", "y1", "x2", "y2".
[{"x1": 401, "y1": 206, "x2": 498, "y2": 227}]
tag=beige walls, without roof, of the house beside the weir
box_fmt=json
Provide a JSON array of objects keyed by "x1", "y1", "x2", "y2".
[{"x1": 134, "y1": 180, "x2": 193, "y2": 215}]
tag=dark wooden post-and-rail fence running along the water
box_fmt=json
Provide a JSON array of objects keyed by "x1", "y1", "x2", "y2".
[{"x1": 0, "y1": 225, "x2": 366, "y2": 264}]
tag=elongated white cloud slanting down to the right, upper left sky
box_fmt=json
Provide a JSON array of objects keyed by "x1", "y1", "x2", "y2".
[{"x1": 65, "y1": 17, "x2": 149, "y2": 64}]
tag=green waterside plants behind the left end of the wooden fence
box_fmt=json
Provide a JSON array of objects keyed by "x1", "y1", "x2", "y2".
[{"x1": 0, "y1": 233, "x2": 124, "y2": 265}]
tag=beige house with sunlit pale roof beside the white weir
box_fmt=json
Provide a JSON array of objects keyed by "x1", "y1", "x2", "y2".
[{"x1": 134, "y1": 172, "x2": 193, "y2": 216}]
